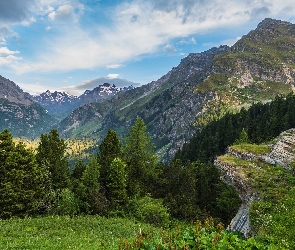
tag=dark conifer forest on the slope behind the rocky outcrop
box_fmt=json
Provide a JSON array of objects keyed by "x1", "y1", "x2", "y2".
[{"x1": 174, "y1": 94, "x2": 295, "y2": 163}]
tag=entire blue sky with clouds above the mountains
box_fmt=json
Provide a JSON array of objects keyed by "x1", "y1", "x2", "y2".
[{"x1": 0, "y1": 0, "x2": 295, "y2": 95}]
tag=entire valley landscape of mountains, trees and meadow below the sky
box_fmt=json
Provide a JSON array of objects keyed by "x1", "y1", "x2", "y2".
[{"x1": 0, "y1": 18, "x2": 295, "y2": 249}]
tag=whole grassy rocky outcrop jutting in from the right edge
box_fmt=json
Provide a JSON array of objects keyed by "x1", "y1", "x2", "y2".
[{"x1": 215, "y1": 129, "x2": 295, "y2": 249}]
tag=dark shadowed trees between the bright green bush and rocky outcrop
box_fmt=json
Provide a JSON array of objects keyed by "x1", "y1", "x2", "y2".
[{"x1": 161, "y1": 160, "x2": 241, "y2": 224}]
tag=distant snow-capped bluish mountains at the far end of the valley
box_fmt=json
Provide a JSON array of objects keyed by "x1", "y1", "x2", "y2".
[{"x1": 30, "y1": 83, "x2": 133, "y2": 120}]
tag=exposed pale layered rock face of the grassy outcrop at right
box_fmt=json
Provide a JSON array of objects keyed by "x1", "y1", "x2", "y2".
[{"x1": 214, "y1": 129, "x2": 295, "y2": 236}]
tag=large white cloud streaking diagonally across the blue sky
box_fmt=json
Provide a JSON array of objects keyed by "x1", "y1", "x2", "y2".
[{"x1": 8, "y1": 0, "x2": 295, "y2": 73}]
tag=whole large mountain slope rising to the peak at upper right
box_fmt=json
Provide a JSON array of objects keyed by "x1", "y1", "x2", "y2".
[{"x1": 58, "y1": 19, "x2": 295, "y2": 159}]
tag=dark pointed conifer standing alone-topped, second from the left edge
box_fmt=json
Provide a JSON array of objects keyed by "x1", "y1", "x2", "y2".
[{"x1": 36, "y1": 129, "x2": 70, "y2": 190}]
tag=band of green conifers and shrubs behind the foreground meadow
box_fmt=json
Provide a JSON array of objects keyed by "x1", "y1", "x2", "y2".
[{"x1": 0, "y1": 118, "x2": 240, "y2": 225}]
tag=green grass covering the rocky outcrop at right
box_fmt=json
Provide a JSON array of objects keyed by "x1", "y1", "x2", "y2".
[{"x1": 218, "y1": 144, "x2": 295, "y2": 249}]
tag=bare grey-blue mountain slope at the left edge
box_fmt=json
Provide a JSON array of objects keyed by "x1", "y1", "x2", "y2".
[{"x1": 0, "y1": 76, "x2": 56, "y2": 138}]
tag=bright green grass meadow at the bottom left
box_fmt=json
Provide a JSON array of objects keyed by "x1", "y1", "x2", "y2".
[{"x1": 0, "y1": 216, "x2": 155, "y2": 250}]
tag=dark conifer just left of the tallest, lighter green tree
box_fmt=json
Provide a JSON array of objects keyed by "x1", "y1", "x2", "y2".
[{"x1": 98, "y1": 129, "x2": 122, "y2": 186}]
